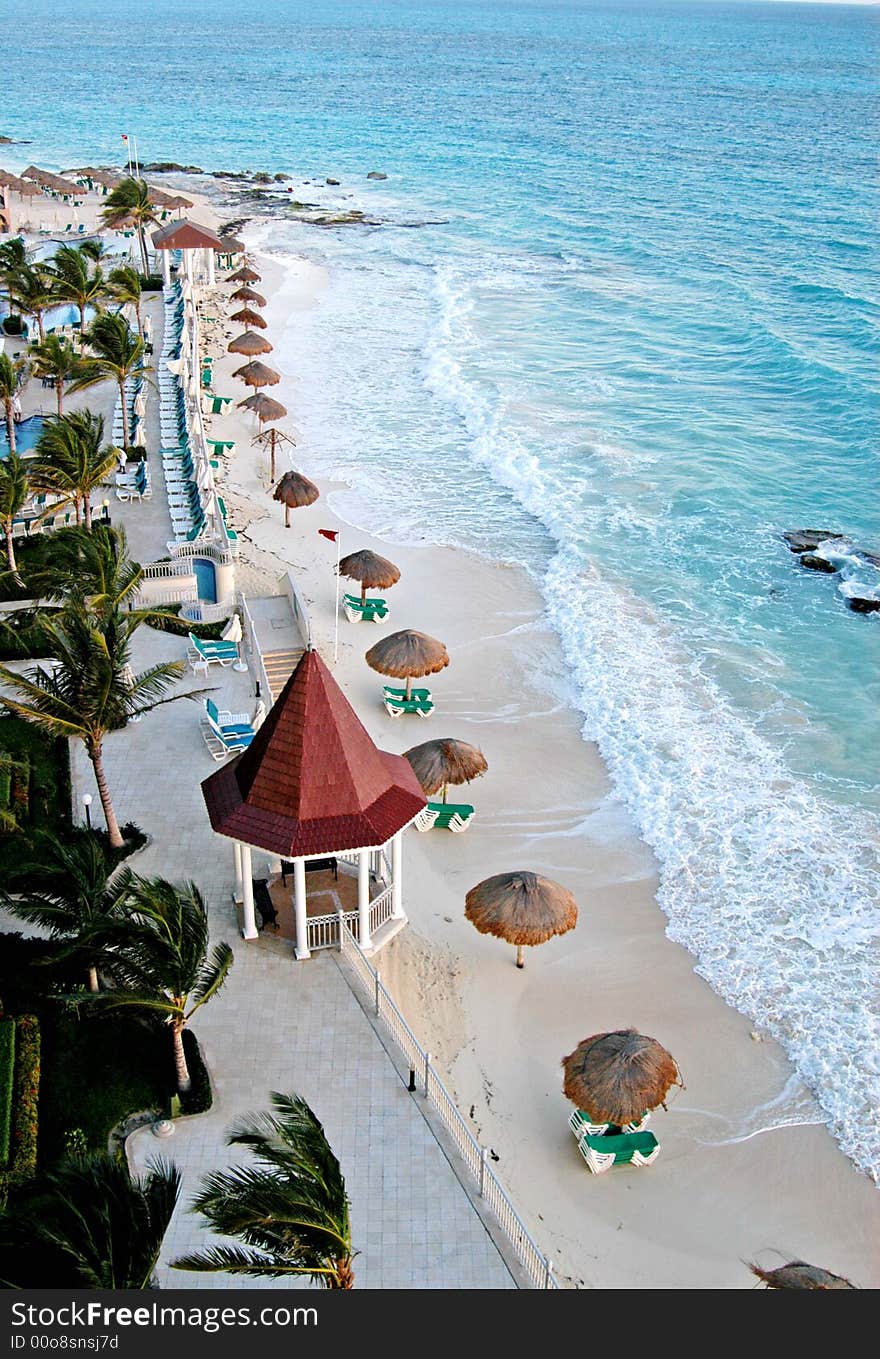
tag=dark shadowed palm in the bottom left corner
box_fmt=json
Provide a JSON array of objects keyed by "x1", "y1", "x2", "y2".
[{"x1": 0, "y1": 1151, "x2": 181, "y2": 1288}]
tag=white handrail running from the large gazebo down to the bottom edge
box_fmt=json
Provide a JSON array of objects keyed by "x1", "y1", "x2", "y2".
[{"x1": 338, "y1": 918, "x2": 560, "y2": 1288}]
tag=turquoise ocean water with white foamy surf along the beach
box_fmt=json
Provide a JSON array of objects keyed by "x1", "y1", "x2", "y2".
[{"x1": 0, "y1": 0, "x2": 880, "y2": 1176}]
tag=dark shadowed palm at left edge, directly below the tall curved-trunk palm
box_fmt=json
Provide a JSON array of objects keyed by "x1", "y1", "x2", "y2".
[{"x1": 0, "y1": 832, "x2": 130, "y2": 992}]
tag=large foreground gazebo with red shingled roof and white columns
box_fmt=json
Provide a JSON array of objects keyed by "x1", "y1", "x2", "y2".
[{"x1": 202, "y1": 648, "x2": 425, "y2": 958}]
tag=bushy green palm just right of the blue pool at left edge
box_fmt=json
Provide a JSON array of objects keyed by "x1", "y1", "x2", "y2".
[{"x1": 30, "y1": 410, "x2": 120, "y2": 529}]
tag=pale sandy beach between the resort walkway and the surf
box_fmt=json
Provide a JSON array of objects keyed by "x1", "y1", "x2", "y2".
[{"x1": 194, "y1": 219, "x2": 880, "y2": 1287}]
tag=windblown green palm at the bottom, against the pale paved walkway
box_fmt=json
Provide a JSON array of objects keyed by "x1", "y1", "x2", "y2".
[{"x1": 172, "y1": 1093, "x2": 354, "y2": 1288}]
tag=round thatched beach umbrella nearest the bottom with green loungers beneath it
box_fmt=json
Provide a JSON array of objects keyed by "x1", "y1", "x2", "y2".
[{"x1": 562, "y1": 1029, "x2": 683, "y2": 1127}]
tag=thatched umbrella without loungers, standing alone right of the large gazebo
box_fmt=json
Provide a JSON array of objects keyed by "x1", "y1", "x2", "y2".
[{"x1": 464, "y1": 871, "x2": 577, "y2": 968}]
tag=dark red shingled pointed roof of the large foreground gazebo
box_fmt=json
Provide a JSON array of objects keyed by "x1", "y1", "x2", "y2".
[{"x1": 202, "y1": 651, "x2": 425, "y2": 859}]
